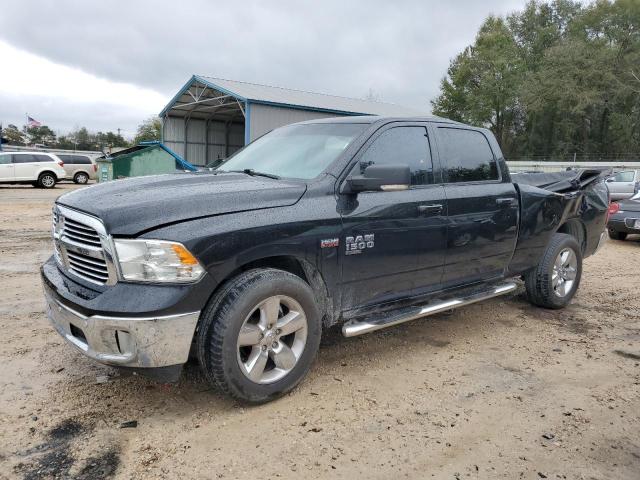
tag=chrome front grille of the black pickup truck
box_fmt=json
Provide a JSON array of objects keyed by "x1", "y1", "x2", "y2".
[{"x1": 52, "y1": 205, "x2": 116, "y2": 285}]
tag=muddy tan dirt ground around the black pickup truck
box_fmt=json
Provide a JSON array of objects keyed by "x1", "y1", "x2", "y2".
[{"x1": 0, "y1": 185, "x2": 640, "y2": 480}]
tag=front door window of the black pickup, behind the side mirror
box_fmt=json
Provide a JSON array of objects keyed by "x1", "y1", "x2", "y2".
[{"x1": 356, "y1": 127, "x2": 433, "y2": 185}]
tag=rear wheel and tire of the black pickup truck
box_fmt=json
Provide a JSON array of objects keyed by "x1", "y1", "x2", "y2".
[{"x1": 525, "y1": 233, "x2": 582, "y2": 309}]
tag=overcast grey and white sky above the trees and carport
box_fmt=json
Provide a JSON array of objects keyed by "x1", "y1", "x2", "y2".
[{"x1": 0, "y1": 0, "x2": 536, "y2": 136}]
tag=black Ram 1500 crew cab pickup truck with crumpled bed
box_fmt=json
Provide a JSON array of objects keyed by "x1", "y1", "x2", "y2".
[{"x1": 42, "y1": 117, "x2": 609, "y2": 402}]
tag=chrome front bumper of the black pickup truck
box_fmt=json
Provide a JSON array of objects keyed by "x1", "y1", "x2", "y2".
[{"x1": 42, "y1": 259, "x2": 200, "y2": 371}]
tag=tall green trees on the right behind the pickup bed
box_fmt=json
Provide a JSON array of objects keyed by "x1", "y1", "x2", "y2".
[{"x1": 431, "y1": 0, "x2": 640, "y2": 160}]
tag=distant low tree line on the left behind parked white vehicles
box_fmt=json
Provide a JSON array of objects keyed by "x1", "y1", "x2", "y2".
[{"x1": 2, "y1": 117, "x2": 162, "y2": 151}]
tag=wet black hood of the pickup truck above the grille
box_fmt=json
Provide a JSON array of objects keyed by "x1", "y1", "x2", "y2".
[{"x1": 57, "y1": 172, "x2": 306, "y2": 236}]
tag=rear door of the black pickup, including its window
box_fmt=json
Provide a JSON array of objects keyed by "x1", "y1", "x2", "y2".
[{"x1": 435, "y1": 126, "x2": 518, "y2": 287}]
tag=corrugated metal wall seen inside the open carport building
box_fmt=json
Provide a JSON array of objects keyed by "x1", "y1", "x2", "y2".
[{"x1": 163, "y1": 117, "x2": 244, "y2": 165}]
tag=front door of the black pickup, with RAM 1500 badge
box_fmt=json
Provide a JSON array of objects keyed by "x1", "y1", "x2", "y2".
[{"x1": 338, "y1": 123, "x2": 446, "y2": 311}]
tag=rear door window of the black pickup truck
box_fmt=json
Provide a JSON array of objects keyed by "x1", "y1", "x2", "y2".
[{"x1": 438, "y1": 127, "x2": 500, "y2": 183}]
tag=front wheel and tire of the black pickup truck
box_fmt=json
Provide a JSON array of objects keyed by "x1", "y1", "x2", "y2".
[{"x1": 197, "y1": 269, "x2": 322, "y2": 403}]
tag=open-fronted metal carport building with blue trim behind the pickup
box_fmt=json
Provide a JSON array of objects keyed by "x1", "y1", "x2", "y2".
[{"x1": 160, "y1": 75, "x2": 425, "y2": 165}]
